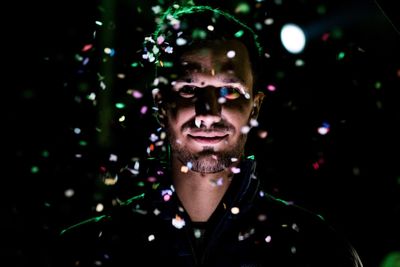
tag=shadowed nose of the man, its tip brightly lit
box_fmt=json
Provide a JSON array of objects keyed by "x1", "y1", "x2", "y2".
[{"x1": 195, "y1": 86, "x2": 221, "y2": 127}]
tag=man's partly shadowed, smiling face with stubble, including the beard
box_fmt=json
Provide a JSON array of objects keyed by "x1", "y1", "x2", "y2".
[{"x1": 159, "y1": 40, "x2": 262, "y2": 173}]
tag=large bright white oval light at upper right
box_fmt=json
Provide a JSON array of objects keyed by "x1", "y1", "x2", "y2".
[{"x1": 281, "y1": 23, "x2": 306, "y2": 54}]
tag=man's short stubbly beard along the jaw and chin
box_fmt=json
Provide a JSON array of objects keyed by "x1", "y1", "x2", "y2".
[{"x1": 167, "y1": 126, "x2": 247, "y2": 173}]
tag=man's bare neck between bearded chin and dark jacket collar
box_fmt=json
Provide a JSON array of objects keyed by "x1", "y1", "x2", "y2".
[{"x1": 172, "y1": 158, "x2": 238, "y2": 222}]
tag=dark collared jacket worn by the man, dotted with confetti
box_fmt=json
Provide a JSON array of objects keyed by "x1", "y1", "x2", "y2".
[{"x1": 54, "y1": 160, "x2": 362, "y2": 267}]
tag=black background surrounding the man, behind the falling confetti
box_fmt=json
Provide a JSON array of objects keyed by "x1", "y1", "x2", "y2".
[{"x1": 6, "y1": 0, "x2": 400, "y2": 267}]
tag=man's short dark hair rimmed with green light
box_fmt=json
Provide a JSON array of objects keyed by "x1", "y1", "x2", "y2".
[{"x1": 144, "y1": 5, "x2": 262, "y2": 92}]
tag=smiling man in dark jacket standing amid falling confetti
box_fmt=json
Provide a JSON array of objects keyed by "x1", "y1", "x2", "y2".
[{"x1": 55, "y1": 6, "x2": 362, "y2": 267}]
